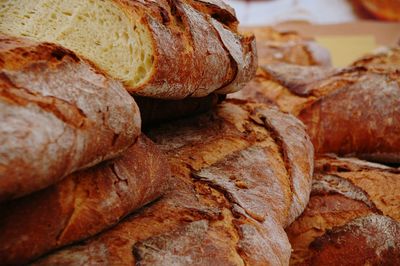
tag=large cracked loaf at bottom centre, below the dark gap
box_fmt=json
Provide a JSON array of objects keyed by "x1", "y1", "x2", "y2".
[{"x1": 31, "y1": 101, "x2": 313, "y2": 265}]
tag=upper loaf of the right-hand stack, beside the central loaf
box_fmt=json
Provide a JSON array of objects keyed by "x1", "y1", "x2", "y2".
[{"x1": 231, "y1": 64, "x2": 400, "y2": 163}]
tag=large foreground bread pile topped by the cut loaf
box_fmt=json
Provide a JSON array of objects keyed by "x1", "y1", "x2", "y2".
[{"x1": 0, "y1": 0, "x2": 314, "y2": 265}]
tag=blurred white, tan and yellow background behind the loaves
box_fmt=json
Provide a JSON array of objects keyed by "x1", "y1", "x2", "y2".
[{"x1": 230, "y1": 0, "x2": 400, "y2": 66}]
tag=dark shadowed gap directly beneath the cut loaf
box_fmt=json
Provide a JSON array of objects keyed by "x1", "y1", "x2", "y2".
[{"x1": 135, "y1": 93, "x2": 226, "y2": 127}]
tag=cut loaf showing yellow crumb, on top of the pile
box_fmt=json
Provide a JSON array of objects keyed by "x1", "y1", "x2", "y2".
[{"x1": 0, "y1": 0, "x2": 256, "y2": 99}]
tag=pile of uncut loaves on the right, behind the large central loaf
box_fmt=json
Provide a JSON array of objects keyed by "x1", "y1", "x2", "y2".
[{"x1": 229, "y1": 28, "x2": 400, "y2": 265}]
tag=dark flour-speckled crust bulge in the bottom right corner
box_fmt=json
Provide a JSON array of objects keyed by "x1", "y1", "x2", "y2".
[{"x1": 309, "y1": 214, "x2": 400, "y2": 266}]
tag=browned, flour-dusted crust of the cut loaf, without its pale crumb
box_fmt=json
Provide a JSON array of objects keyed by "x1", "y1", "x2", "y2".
[{"x1": 128, "y1": 0, "x2": 257, "y2": 99}]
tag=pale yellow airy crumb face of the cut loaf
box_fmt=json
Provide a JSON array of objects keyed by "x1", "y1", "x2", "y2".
[{"x1": 0, "y1": 0, "x2": 154, "y2": 87}]
